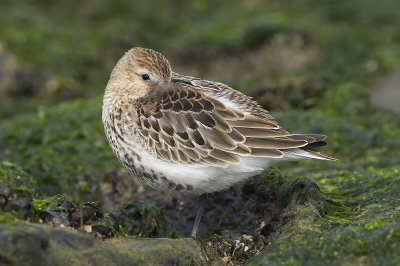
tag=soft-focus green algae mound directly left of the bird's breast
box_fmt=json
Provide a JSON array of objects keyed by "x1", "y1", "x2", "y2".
[{"x1": 0, "y1": 98, "x2": 118, "y2": 201}]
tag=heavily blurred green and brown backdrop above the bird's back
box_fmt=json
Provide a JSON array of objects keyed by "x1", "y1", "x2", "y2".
[{"x1": 0, "y1": 0, "x2": 400, "y2": 113}]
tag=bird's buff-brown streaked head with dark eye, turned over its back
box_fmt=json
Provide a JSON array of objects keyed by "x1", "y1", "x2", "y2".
[{"x1": 106, "y1": 47, "x2": 171, "y2": 98}]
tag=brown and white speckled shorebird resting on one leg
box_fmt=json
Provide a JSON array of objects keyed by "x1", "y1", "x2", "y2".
[{"x1": 102, "y1": 47, "x2": 336, "y2": 237}]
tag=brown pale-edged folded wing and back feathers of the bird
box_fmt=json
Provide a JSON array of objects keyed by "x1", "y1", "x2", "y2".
[{"x1": 130, "y1": 79, "x2": 332, "y2": 166}]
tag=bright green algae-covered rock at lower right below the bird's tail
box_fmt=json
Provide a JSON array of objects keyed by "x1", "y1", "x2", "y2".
[{"x1": 248, "y1": 167, "x2": 400, "y2": 265}]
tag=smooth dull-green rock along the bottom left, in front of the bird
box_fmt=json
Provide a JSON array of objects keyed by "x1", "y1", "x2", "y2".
[{"x1": 0, "y1": 222, "x2": 216, "y2": 265}]
